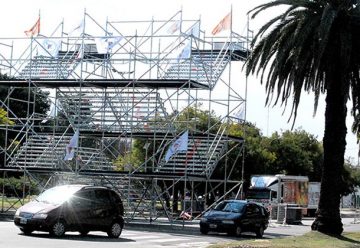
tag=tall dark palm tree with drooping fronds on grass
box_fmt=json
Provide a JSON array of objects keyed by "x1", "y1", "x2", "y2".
[{"x1": 246, "y1": 0, "x2": 360, "y2": 235}]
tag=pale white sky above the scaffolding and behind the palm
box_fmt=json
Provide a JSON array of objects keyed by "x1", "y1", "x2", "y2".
[{"x1": 0, "y1": 0, "x2": 358, "y2": 164}]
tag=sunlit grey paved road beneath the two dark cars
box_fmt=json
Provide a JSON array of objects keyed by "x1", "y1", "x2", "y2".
[{"x1": 0, "y1": 218, "x2": 360, "y2": 248}]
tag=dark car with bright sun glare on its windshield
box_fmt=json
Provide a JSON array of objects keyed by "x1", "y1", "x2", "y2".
[{"x1": 14, "y1": 185, "x2": 124, "y2": 238}]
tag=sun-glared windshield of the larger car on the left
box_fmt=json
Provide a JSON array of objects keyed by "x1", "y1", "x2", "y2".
[{"x1": 36, "y1": 185, "x2": 80, "y2": 205}]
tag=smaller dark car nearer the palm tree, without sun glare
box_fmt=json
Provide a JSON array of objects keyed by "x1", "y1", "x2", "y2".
[{"x1": 200, "y1": 200, "x2": 269, "y2": 238}]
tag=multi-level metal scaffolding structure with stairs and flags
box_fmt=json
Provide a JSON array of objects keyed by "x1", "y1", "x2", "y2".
[{"x1": 0, "y1": 11, "x2": 249, "y2": 221}]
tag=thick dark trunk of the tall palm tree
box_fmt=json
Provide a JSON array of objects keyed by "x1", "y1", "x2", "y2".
[{"x1": 311, "y1": 68, "x2": 349, "y2": 235}]
